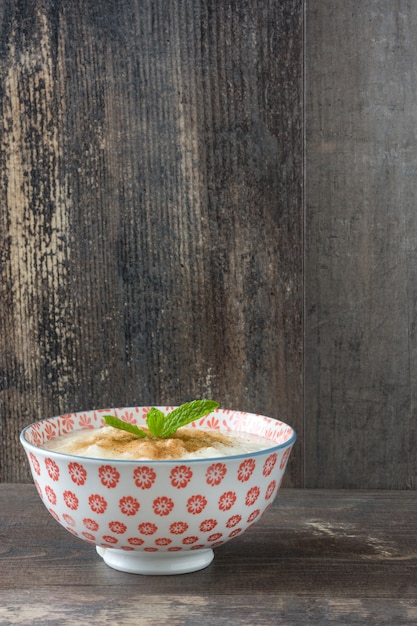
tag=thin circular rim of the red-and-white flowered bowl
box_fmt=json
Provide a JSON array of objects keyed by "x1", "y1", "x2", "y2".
[{"x1": 19, "y1": 405, "x2": 297, "y2": 466}]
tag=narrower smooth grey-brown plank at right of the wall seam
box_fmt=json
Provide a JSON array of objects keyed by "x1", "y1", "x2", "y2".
[{"x1": 304, "y1": 0, "x2": 417, "y2": 489}]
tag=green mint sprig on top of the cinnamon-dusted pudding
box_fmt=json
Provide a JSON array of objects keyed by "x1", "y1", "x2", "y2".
[{"x1": 103, "y1": 400, "x2": 220, "y2": 439}]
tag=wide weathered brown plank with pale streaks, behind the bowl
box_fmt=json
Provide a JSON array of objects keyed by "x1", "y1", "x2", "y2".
[{"x1": 0, "y1": 0, "x2": 303, "y2": 484}]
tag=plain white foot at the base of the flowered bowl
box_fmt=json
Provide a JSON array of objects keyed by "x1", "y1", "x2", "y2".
[{"x1": 96, "y1": 546, "x2": 214, "y2": 575}]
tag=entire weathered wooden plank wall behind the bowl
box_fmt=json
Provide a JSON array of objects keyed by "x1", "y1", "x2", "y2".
[{"x1": 0, "y1": 0, "x2": 417, "y2": 488}]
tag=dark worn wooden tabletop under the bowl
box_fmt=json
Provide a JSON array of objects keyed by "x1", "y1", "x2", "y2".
[{"x1": 0, "y1": 484, "x2": 417, "y2": 626}]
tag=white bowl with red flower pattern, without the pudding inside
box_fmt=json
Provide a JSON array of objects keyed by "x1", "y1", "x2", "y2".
[{"x1": 20, "y1": 407, "x2": 296, "y2": 575}]
